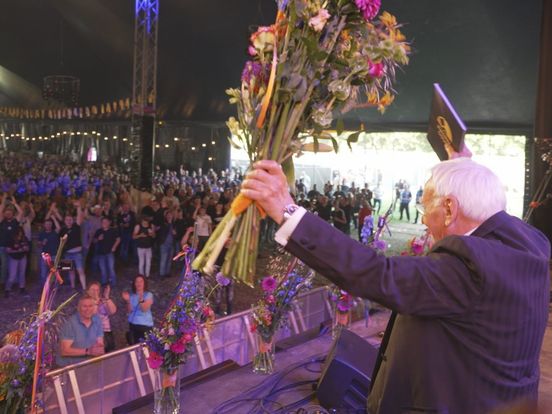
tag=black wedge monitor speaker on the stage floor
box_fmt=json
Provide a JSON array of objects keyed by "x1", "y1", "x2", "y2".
[{"x1": 316, "y1": 329, "x2": 378, "y2": 413}]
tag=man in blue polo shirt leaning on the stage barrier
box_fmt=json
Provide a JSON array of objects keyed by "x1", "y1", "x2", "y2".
[{"x1": 56, "y1": 295, "x2": 104, "y2": 367}]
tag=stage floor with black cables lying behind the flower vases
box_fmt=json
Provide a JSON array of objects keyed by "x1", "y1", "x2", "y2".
[{"x1": 126, "y1": 307, "x2": 552, "y2": 414}]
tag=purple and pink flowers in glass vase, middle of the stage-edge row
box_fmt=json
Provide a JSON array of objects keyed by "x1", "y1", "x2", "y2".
[{"x1": 251, "y1": 260, "x2": 314, "y2": 374}]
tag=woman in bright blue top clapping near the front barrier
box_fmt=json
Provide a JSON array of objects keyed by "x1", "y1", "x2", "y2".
[{"x1": 122, "y1": 275, "x2": 153, "y2": 345}]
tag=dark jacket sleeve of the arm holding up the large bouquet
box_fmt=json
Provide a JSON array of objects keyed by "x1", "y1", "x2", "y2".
[{"x1": 285, "y1": 213, "x2": 483, "y2": 317}]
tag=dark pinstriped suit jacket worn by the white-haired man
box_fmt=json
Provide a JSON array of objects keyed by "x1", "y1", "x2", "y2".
[{"x1": 286, "y1": 212, "x2": 550, "y2": 414}]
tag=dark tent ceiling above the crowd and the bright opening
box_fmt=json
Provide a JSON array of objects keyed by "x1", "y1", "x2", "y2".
[{"x1": 0, "y1": 0, "x2": 541, "y2": 132}]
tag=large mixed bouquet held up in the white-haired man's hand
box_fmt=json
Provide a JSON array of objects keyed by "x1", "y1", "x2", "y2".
[{"x1": 194, "y1": 0, "x2": 410, "y2": 286}]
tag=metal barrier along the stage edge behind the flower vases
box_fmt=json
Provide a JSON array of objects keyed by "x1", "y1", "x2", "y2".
[{"x1": 41, "y1": 287, "x2": 331, "y2": 414}]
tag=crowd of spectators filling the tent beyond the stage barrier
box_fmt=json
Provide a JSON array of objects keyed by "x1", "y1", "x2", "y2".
[{"x1": 0, "y1": 154, "x2": 418, "y2": 365}]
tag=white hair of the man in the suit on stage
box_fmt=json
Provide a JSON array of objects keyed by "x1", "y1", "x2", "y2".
[{"x1": 428, "y1": 158, "x2": 506, "y2": 222}]
